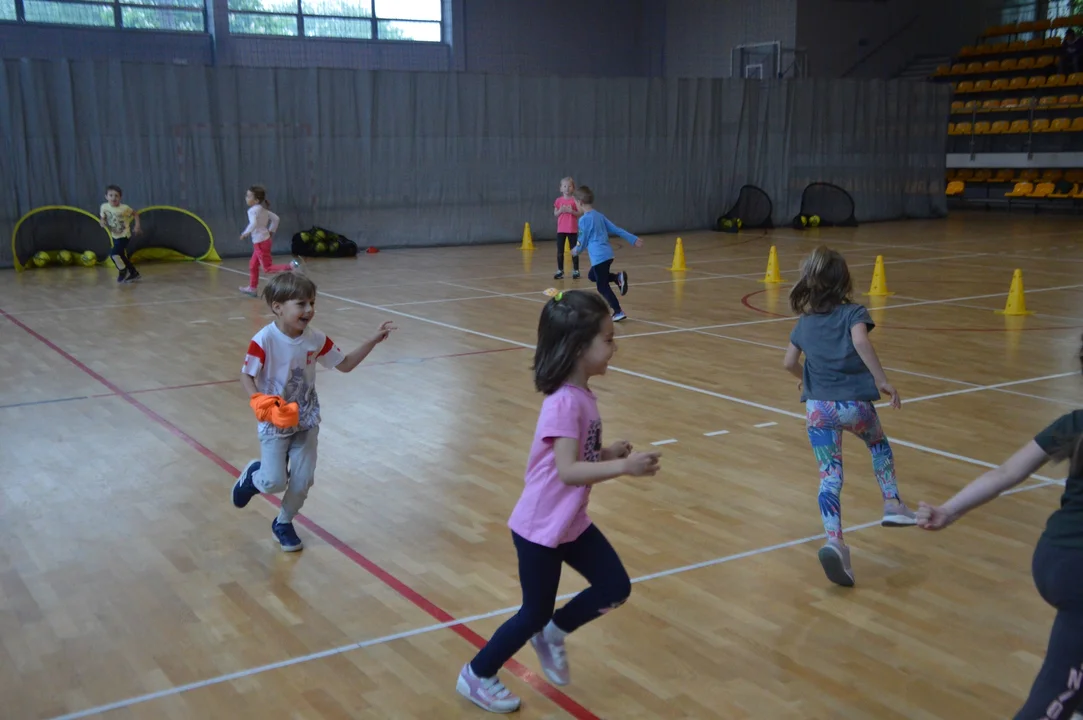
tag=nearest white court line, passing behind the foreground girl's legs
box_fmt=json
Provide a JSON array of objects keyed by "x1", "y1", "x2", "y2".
[{"x1": 52, "y1": 472, "x2": 1060, "y2": 720}]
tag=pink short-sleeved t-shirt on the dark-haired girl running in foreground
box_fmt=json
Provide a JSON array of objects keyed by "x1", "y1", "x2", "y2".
[{"x1": 508, "y1": 385, "x2": 602, "y2": 548}]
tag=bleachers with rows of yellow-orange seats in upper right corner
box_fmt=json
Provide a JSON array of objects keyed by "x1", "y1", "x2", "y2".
[{"x1": 930, "y1": 15, "x2": 1083, "y2": 211}]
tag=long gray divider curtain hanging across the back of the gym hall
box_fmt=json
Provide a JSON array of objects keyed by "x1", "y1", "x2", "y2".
[{"x1": 0, "y1": 61, "x2": 950, "y2": 266}]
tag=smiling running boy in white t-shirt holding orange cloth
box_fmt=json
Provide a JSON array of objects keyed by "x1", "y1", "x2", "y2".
[{"x1": 233, "y1": 273, "x2": 395, "y2": 552}]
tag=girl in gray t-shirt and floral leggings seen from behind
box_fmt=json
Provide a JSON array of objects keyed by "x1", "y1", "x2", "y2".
[{"x1": 784, "y1": 246, "x2": 915, "y2": 587}]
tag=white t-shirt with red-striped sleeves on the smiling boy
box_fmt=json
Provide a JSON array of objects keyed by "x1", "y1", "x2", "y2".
[{"x1": 240, "y1": 323, "x2": 345, "y2": 437}]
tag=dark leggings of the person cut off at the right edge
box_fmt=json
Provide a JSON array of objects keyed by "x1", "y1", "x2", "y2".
[{"x1": 1015, "y1": 539, "x2": 1083, "y2": 720}]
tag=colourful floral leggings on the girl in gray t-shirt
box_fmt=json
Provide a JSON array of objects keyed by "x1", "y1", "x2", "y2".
[{"x1": 805, "y1": 400, "x2": 899, "y2": 539}]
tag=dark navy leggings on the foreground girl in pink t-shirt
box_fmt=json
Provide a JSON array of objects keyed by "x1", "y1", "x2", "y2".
[{"x1": 470, "y1": 525, "x2": 631, "y2": 678}]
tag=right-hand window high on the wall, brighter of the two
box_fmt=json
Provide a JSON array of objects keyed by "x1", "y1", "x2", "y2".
[{"x1": 229, "y1": 0, "x2": 443, "y2": 42}]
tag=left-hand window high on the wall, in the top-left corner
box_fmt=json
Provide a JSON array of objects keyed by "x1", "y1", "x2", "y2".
[{"x1": 9, "y1": 0, "x2": 207, "y2": 32}]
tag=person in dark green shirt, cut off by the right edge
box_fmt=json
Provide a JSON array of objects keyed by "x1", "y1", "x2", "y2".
[{"x1": 917, "y1": 342, "x2": 1083, "y2": 720}]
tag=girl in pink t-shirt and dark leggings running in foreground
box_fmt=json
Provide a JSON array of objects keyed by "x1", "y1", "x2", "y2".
[{"x1": 456, "y1": 290, "x2": 660, "y2": 712}]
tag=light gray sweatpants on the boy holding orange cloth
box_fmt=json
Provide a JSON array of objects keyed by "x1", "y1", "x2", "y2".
[{"x1": 252, "y1": 426, "x2": 319, "y2": 523}]
